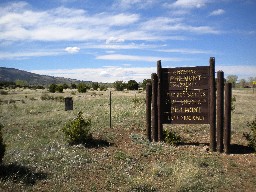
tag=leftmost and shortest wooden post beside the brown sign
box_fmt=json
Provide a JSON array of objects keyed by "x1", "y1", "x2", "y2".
[{"x1": 146, "y1": 83, "x2": 152, "y2": 141}]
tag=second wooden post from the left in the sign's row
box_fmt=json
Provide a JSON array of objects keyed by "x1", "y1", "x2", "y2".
[{"x1": 151, "y1": 73, "x2": 158, "y2": 141}]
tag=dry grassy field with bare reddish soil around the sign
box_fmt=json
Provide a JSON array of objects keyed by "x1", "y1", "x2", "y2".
[{"x1": 0, "y1": 89, "x2": 256, "y2": 192}]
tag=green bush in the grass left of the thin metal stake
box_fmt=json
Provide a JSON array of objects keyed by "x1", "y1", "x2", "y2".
[{"x1": 62, "y1": 111, "x2": 92, "y2": 145}]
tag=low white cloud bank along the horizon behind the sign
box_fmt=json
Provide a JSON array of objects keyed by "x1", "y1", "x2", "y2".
[{"x1": 31, "y1": 65, "x2": 256, "y2": 82}]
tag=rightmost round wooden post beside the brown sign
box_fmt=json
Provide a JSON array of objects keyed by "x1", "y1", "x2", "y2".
[{"x1": 224, "y1": 83, "x2": 232, "y2": 154}]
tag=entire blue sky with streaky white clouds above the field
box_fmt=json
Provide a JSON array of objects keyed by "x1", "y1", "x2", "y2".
[{"x1": 0, "y1": 0, "x2": 256, "y2": 82}]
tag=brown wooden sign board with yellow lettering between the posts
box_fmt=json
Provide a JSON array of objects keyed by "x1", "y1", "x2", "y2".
[{"x1": 161, "y1": 66, "x2": 209, "y2": 124}]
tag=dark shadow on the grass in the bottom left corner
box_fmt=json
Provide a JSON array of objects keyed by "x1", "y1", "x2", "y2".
[{"x1": 0, "y1": 163, "x2": 47, "y2": 185}]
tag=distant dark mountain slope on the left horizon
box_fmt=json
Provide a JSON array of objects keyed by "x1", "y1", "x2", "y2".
[{"x1": 0, "y1": 67, "x2": 89, "y2": 85}]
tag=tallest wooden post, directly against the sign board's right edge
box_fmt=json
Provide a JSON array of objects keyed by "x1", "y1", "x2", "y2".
[{"x1": 209, "y1": 57, "x2": 216, "y2": 151}]
